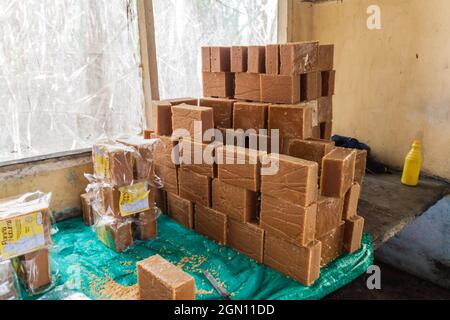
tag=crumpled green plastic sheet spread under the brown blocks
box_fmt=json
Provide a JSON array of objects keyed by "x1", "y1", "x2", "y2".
[{"x1": 26, "y1": 216, "x2": 373, "y2": 300}]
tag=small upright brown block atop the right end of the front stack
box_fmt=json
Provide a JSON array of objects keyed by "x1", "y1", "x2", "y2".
[{"x1": 320, "y1": 148, "x2": 356, "y2": 198}]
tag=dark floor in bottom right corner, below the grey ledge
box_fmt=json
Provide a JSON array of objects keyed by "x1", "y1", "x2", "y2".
[{"x1": 325, "y1": 262, "x2": 450, "y2": 300}]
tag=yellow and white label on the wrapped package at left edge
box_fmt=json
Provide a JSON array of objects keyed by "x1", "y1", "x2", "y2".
[{"x1": 0, "y1": 212, "x2": 46, "y2": 260}]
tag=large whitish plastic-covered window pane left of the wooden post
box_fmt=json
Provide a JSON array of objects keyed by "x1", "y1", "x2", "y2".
[{"x1": 0, "y1": 0, "x2": 143, "y2": 162}]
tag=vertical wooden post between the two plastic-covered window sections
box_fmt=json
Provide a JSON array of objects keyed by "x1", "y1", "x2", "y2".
[{"x1": 137, "y1": 0, "x2": 160, "y2": 129}]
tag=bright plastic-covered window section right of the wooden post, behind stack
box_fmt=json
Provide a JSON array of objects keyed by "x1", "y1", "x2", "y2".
[{"x1": 153, "y1": 0, "x2": 278, "y2": 99}]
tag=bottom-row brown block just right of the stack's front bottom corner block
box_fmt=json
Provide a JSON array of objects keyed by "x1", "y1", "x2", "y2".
[{"x1": 318, "y1": 221, "x2": 345, "y2": 267}]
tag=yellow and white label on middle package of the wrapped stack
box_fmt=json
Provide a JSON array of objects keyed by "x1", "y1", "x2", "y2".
[{"x1": 119, "y1": 182, "x2": 150, "y2": 217}]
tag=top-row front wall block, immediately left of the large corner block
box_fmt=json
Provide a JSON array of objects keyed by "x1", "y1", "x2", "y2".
[{"x1": 217, "y1": 146, "x2": 263, "y2": 192}]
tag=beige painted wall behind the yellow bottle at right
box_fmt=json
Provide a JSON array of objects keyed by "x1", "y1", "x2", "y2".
[{"x1": 292, "y1": 0, "x2": 450, "y2": 179}]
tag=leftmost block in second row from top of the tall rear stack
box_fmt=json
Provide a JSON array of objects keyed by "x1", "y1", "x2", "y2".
[{"x1": 203, "y1": 72, "x2": 234, "y2": 98}]
